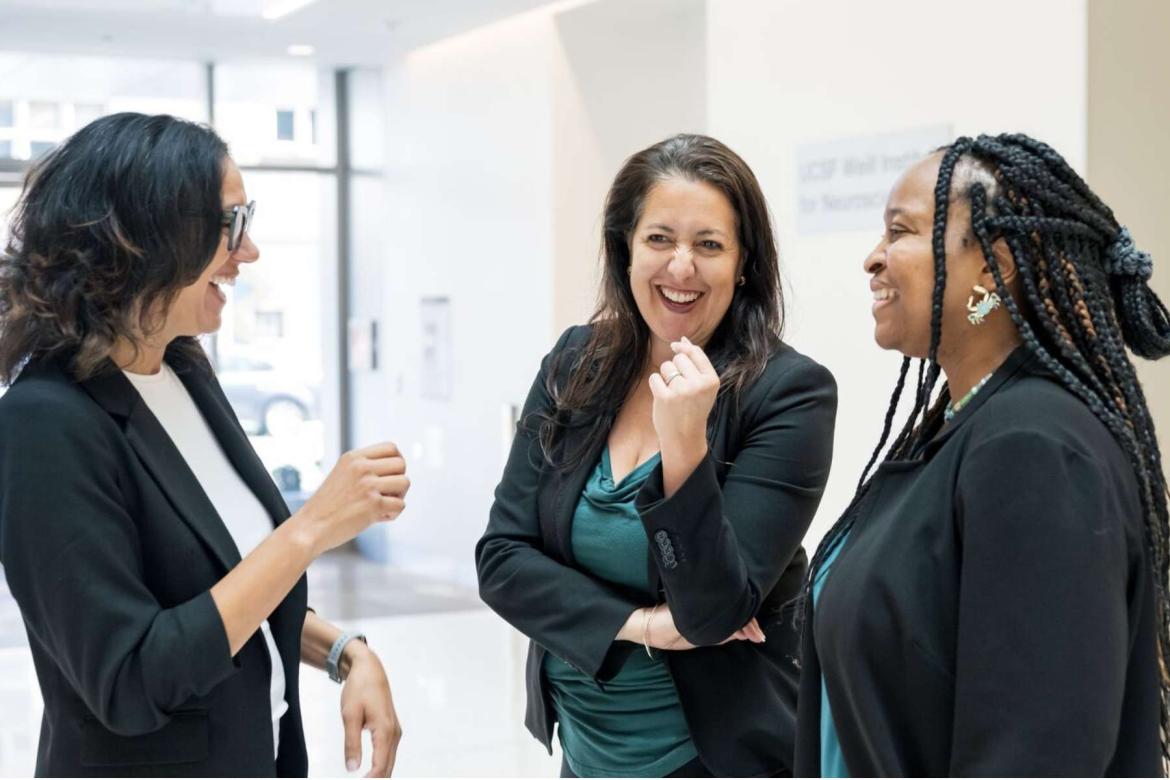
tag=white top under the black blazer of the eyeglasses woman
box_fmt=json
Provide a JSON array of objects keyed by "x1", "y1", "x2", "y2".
[{"x1": 123, "y1": 363, "x2": 289, "y2": 752}]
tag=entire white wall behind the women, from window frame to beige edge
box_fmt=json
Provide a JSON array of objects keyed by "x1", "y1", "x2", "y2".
[{"x1": 374, "y1": 0, "x2": 1087, "y2": 582}]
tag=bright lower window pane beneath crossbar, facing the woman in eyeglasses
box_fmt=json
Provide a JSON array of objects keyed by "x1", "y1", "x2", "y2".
[{"x1": 214, "y1": 170, "x2": 337, "y2": 511}]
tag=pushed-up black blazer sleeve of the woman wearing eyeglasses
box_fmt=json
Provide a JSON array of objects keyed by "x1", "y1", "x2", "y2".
[{"x1": 0, "y1": 398, "x2": 236, "y2": 736}]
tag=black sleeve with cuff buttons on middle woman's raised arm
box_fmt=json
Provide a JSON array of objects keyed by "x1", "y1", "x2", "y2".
[{"x1": 638, "y1": 360, "x2": 837, "y2": 644}]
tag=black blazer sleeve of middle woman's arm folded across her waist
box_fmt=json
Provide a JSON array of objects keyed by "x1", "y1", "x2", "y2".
[{"x1": 475, "y1": 329, "x2": 641, "y2": 677}]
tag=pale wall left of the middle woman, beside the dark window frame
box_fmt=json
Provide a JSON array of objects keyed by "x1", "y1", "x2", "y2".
[{"x1": 369, "y1": 0, "x2": 707, "y2": 584}]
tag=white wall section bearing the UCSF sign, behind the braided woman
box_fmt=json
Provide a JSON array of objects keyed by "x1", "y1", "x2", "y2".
[{"x1": 707, "y1": 0, "x2": 1087, "y2": 546}]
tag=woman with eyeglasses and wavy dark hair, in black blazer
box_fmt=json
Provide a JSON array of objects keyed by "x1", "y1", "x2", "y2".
[{"x1": 0, "y1": 113, "x2": 410, "y2": 776}]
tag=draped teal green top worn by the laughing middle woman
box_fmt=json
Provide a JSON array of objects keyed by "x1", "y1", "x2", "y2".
[{"x1": 544, "y1": 448, "x2": 698, "y2": 778}]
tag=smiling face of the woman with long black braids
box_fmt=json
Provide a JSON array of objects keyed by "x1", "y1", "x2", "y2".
[{"x1": 865, "y1": 154, "x2": 990, "y2": 358}]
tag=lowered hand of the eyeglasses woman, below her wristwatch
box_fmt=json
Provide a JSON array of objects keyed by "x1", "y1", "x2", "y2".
[{"x1": 342, "y1": 642, "x2": 402, "y2": 778}]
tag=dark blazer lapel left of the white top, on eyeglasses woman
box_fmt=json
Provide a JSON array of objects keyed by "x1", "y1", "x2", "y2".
[{"x1": 81, "y1": 364, "x2": 240, "y2": 571}]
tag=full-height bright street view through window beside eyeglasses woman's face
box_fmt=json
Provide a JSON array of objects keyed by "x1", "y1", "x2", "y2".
[{"x1": 214, "y1": 61, "x2": 337, "y2": 509}]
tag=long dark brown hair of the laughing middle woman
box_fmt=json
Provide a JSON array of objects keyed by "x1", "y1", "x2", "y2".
[{"x1": 541, "y1": 134, "x2": 784, "y2": 468}]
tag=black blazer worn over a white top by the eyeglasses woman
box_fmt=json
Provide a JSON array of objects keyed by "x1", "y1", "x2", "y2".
[{"x1": 0, "y1": 350, "x2": 308, "y2": 776}]
